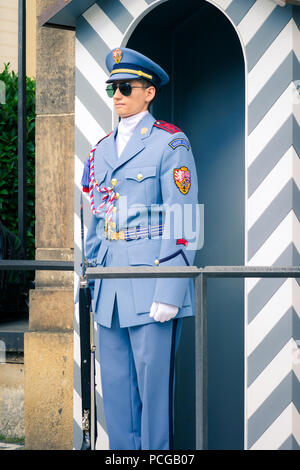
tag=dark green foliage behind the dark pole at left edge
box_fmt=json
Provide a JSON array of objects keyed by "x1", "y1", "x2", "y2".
[{"x1": 0, "y1": 63, "x2": 35, "y2": 259}]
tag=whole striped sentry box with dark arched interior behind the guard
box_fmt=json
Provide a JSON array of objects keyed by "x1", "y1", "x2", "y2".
[{"x1": 42, "y1": 0, "x2": 300, "y2": 449}]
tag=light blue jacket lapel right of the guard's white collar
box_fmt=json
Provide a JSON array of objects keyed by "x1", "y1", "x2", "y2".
[{"x1": 114, "y1": 114, "x2": 155, "y2": 170}]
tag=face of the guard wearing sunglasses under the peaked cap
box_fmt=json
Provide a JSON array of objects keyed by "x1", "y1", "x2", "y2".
[{"x1": 113, "y1": 80, "x2": 155, "y2": 118}]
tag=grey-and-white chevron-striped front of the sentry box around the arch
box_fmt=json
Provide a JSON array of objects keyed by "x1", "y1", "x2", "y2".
[{"x1": 74, "y1": 0, "x2": 300, "y2": 449}]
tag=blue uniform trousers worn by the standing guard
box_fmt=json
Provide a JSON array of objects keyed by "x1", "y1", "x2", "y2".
[{"x1": 98, "y1": 300, "x2": 182, "y2": 450}]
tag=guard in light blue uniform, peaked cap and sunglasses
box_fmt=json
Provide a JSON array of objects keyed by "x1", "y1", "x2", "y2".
[{"x1": 82, "y1": 48, "x2": 198, "y2": 450}]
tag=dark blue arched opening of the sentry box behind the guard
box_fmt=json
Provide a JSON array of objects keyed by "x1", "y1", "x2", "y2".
[{"x1": 124, "y1": 0, "x2": 245, "y2": 449}]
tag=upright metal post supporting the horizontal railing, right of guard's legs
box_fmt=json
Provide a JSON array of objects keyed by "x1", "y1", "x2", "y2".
[{"x1": 195, "y1": 273, "x2": 208, "y2": 450}]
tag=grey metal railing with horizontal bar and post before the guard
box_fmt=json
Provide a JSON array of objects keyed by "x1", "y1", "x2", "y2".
[{"x1": 0, "y1": 260, "x2": 300, "y2": 450}]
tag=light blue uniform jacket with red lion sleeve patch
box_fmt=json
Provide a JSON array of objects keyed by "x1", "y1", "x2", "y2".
[{"x1": 86, "y1": 114, "x2": 198, "y2": 327}]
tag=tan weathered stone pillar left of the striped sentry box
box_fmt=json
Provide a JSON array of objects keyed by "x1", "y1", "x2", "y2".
[{"x1": 24, "y1": 0, "x2": 75, "y2": 450}]
